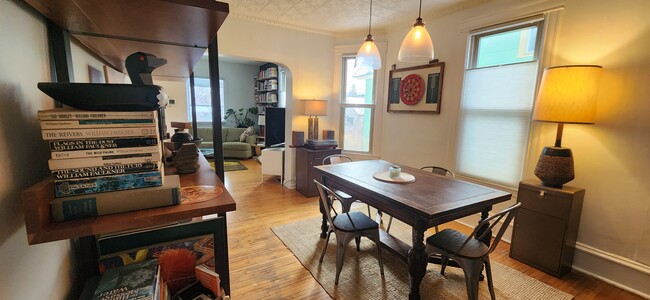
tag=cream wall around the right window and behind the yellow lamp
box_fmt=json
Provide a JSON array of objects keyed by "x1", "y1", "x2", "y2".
[{"x1": 368, "y1": 0, "x2": 650, "y2": 297}]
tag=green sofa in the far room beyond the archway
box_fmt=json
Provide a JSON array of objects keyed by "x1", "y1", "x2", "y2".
[{"x1": 197, "y1": 127, "x2": 257, "y2": 159}]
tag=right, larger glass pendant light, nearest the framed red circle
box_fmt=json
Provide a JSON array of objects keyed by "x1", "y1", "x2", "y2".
[{"x1": 397, "y1": 0, "x2": 433, "y2": 63}]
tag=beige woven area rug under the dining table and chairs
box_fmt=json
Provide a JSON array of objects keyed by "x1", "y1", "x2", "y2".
[{"x1": 271, "y1": 218, "x2": 573, "y2": 300}]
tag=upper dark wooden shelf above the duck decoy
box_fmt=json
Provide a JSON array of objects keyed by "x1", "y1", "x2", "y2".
[{"x1": 25, "y1": 0, "x2": 229, "y2": 77}]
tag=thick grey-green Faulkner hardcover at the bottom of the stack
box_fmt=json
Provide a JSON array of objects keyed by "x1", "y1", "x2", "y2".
[{"x1": 50, "y1": 175, "x2": 181, "y2": 222}]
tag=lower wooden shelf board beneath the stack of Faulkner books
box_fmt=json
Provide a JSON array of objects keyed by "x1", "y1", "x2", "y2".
[{"x1": 22, "y1": 156, "x2": 236, "y2": 245}]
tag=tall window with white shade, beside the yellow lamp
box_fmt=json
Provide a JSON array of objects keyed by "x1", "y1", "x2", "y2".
[{"x1": 456, "y1": 17, "x2": 543, "y2": 187}]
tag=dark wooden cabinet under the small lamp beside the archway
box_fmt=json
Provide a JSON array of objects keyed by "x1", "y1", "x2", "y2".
[{"x1": 296, "y1": 148, "x2": 341, "y2": 197}]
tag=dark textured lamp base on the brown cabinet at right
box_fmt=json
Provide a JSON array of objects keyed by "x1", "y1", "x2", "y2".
[{"x1": 535, "y1": 147, "x2": 575, "y2": 187}]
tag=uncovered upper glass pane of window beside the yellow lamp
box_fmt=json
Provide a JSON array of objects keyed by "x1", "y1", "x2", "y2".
[{"x1": 476, "y1": 26, "x2": 537, "y2": 68}]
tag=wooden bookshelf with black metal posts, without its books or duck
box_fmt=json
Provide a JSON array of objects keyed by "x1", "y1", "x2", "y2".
[{"x1": 22, "y1": 0, "x2": 236, "y2": 298}]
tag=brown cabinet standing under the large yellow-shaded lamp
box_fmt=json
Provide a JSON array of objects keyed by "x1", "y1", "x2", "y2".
[{"x1": 510, "y1": 180, "x2": 585, "y2": 277}]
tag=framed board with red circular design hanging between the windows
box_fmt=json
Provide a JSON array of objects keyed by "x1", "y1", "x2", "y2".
[{"x1": 387, "y1": 62, "x2": 445, "y2": 114}]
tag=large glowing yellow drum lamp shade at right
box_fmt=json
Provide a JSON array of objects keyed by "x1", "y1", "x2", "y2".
[{"x1": 533, "y1": 65, "x2": 602, "y2": 124}]
